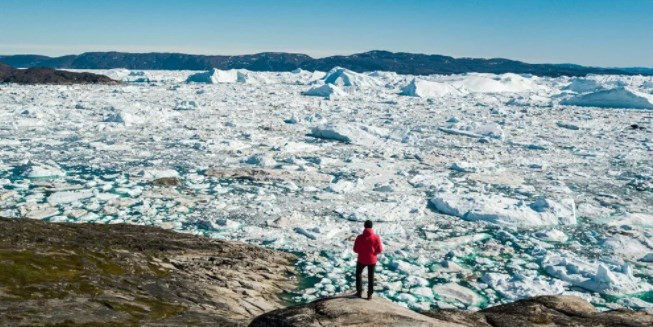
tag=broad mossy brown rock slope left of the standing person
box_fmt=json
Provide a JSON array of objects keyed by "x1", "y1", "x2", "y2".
[{"x1": 0, "y1": 218, "x2": 296, "y2": 326}]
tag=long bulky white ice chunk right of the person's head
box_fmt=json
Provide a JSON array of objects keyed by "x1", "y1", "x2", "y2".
[{"x1": 430, "y1": 192, "x2": 576, "y2": 227}]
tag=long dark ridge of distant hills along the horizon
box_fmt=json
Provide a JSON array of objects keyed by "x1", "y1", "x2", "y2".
[{"x1": 0, "y1": 50, "x2": 653, "y2": 76}]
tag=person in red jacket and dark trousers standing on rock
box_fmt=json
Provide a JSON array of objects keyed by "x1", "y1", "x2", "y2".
[{"x1": 354, "y1": 220, "x2": 383, "y2": 300}]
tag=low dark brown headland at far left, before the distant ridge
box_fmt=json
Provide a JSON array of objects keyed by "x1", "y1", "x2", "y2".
[{"x1": 0, "y1": 63, "x2": 120, "y2": 85}]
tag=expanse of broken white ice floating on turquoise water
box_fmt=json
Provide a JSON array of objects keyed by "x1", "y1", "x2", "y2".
[{"x1": 0, "y1": 68, "x2": 653, "y2": 310}]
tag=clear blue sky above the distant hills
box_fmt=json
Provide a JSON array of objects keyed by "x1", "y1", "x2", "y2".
[{"x1": 0, "y1": 0, "x2": 653, "y2": 67}]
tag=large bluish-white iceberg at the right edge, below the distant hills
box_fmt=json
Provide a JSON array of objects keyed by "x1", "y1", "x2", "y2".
[{"x1": 560, "y1": 87, "x2": 653, "y2": 109}]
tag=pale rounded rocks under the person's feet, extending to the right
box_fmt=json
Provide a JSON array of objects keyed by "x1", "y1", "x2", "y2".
[{"x1": 250, "y1": 296, "x2": 653, "y2": 327}]
